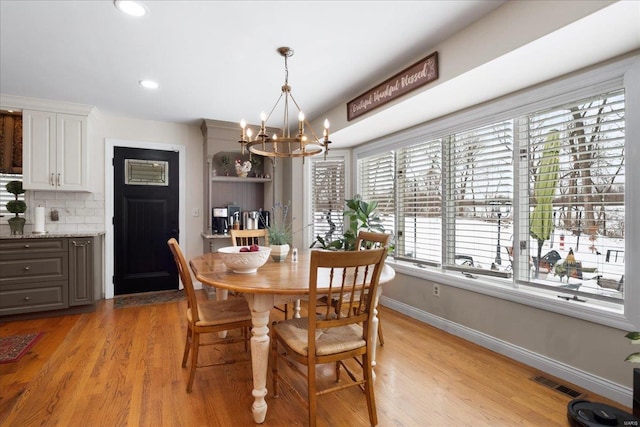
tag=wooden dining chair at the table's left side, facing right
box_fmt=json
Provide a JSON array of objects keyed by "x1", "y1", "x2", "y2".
[{"x1": 167, "y1": 238, "x2": 251, "y2": 393}]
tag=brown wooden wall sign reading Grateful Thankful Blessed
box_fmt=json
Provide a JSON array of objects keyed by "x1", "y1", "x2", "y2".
[{"x1": 347, "y1": 52, "x2": 438, "y2": 121}]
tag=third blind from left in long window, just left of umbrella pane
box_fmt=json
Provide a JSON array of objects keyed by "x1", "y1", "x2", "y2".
[{"x1": 444, "y1": 120, "x2": 513, "y2": 276}]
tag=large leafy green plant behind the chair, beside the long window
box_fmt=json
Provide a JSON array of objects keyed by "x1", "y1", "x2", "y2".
[{"x1": 311, "y1": 194, "x2": 384, "y2": 251}]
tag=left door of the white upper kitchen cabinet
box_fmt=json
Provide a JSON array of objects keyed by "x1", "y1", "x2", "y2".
[{"x1": 22, "y1": 110, "x2": 57, "y2": 190}]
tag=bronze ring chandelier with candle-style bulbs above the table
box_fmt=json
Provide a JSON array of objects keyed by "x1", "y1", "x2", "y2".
[{"x1": 238, "y1": 47, "x2": 331, "y2": 161}]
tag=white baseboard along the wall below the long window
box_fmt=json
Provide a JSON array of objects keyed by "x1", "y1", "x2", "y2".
[{"x1": 380, "y1": 295, "x2": 633, "y2": 408}]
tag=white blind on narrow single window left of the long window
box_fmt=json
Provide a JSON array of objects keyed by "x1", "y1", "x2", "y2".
[{"x1": 311, "y1": 158, "x2": 346, "y2": 241}]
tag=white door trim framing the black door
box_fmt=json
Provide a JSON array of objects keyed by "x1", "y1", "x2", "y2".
[{"x1": 104, "y1": 138, "x2": 187, "y2": 299}]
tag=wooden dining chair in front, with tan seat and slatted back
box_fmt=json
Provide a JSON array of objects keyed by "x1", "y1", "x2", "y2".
[{"x1": 271, "y1": 248, "x2": 387, "y2": 426}]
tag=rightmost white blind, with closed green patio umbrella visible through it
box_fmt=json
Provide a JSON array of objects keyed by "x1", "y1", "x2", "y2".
[{"x1": 519, "y1": 90, "x2": 625, "y2": 298}]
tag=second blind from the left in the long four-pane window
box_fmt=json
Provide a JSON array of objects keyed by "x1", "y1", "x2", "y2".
[{"x1": 396, "y1": 139, "x2": 442, "y2": 265}]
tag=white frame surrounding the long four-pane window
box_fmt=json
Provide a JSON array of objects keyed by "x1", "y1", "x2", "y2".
[{"x1": 352, "y1": 55, "x2": 640, "y2": 330}]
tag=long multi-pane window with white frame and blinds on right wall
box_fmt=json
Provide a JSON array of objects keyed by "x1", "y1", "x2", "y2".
[{"x1": 354, "y1": 56, "x2": 640, "y2": 327}]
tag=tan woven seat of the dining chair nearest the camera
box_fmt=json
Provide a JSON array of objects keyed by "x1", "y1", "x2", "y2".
[{"x1": 274, "y1": 317, "x2": 367, "y2": 356}]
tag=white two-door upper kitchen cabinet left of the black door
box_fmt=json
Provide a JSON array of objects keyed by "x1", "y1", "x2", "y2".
[{"x1": 22, "y1": 110, "x2": 89, "y2": 191}]
